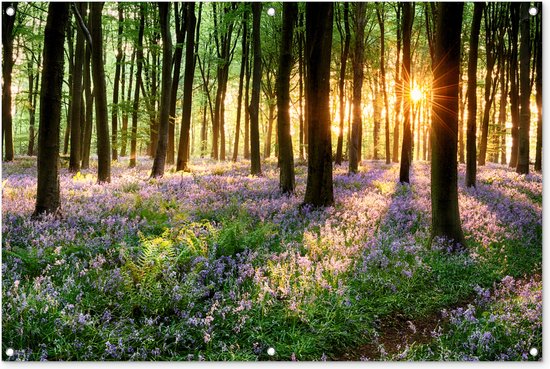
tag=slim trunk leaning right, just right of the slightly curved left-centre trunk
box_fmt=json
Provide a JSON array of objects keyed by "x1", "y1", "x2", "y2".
[{"x1": 176, "y1": 3, "x2": 196, "y2": 171}]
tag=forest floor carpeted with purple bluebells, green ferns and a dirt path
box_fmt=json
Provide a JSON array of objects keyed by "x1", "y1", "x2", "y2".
[{"x1": 2, "y1": 157, "x2": 542, "y2": 360}]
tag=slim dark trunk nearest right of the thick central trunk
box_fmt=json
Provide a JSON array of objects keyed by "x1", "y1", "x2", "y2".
[{"x1": 352, "y1": 2, "x2": 367, "y2": 173}]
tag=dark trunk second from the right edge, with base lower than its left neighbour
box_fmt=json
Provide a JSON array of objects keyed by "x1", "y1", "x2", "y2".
[{"x1": 516, "y1": 2, "x2": 531, "y2": 174}]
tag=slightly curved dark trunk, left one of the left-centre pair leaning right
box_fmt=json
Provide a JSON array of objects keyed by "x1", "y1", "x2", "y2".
[{"x1": 151, "y1": 2, "x2": 172, "y2": 178}]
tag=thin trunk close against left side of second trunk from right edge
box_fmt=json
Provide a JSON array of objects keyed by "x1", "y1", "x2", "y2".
[{"x1": 508, "y1": 2, "x2": 520, "y2": 168}]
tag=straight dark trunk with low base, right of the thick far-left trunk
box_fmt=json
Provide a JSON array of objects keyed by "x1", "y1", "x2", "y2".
[{"x1": 90, "y1": 2, "x2": 111, "y2": 183}]
